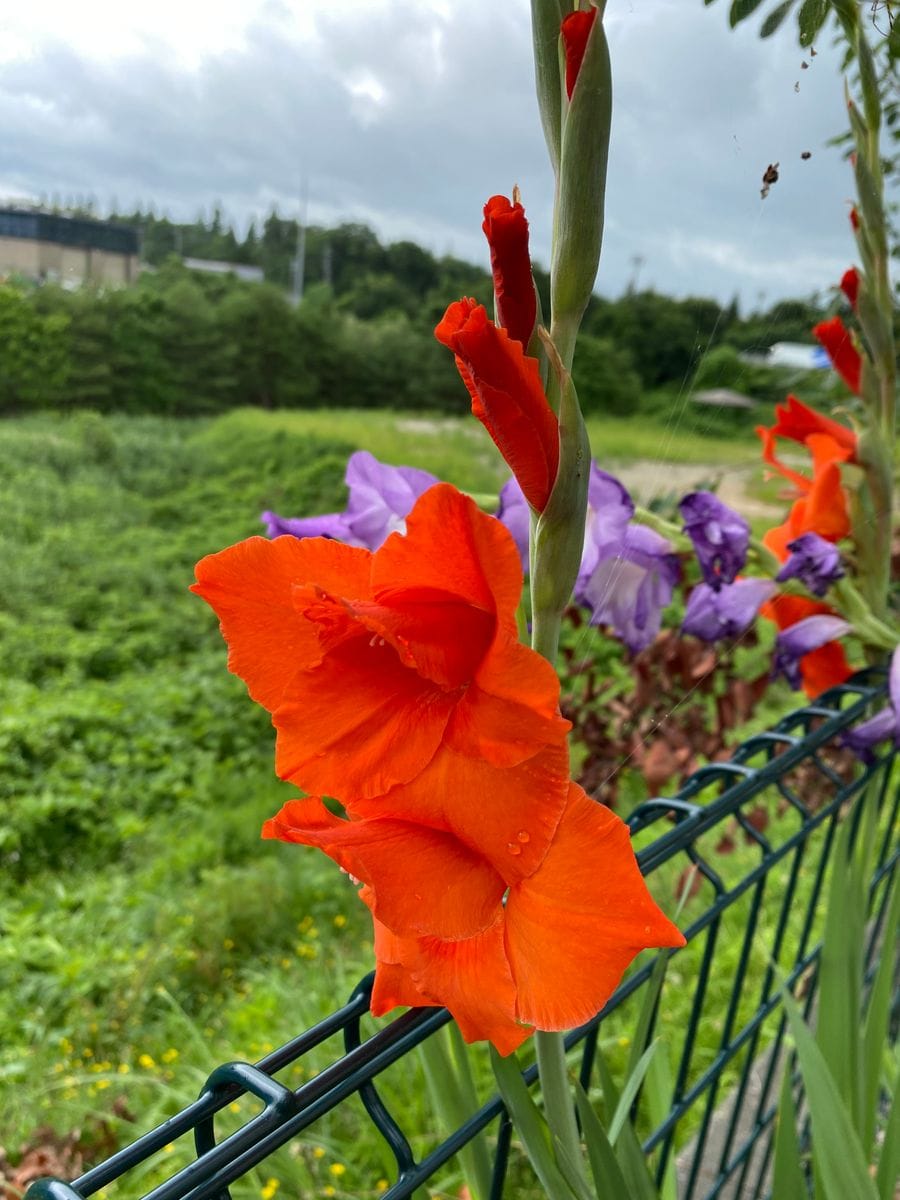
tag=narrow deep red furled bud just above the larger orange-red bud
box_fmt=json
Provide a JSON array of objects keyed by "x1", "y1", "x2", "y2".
[{"x1": 481, "y1": 187, "x2": 538, "y2": 348}]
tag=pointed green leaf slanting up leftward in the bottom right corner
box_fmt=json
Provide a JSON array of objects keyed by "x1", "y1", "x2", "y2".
[{"x1": 784, "y1": 992, "x2": 877, "y2": 1200}]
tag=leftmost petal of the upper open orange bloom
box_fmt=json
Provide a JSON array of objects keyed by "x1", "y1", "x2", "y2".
[{"x1": 191, "y1": 538, "x2": 372, "y2": 712}]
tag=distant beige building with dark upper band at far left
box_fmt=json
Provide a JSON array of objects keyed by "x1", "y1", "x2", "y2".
[{"x1": 0, "y1": 208, "x2": 138, "y2": 287}]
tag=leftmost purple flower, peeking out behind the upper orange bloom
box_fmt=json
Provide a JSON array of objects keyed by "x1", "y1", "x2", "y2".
[{"x1": 262, "y1": 450, "x2": 438, "y2": 550}]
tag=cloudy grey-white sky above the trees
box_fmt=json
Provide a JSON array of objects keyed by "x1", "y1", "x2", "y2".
[{"x1": 0, "y1": 0, "x2": 853, "y2": 308}]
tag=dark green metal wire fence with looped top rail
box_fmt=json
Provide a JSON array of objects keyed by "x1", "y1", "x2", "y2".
[{"x1": 28, "y1": 670, "x2": 900, "y2": 1200}]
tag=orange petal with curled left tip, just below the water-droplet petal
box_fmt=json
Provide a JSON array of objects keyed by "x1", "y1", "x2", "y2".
[{"x1": 263, "y1": 797, "x2": 506, "y2": 938}]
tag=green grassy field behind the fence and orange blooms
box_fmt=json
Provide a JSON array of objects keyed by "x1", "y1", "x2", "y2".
[{"x1": 0, "y1": 410, "x2": 801, "y2": 1200}]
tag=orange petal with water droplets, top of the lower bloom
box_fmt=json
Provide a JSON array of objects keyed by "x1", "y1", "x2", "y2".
[{"x1": 348, "y1": 742, "x2": 569, "y2": 883}]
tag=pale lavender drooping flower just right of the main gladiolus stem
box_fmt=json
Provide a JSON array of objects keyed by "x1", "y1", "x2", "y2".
[{"x1": 575, "y1": 524, "x2": 680, "y2": 654}]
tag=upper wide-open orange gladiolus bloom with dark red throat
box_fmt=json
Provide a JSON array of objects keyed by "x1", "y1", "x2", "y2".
[{"x1": 192, "y1": 484, "x2": 569, "y2": 799}]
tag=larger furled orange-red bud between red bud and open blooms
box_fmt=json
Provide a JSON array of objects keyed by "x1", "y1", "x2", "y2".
[{"x1": 434, "y1": 299, "x2": 559, "y2": 512}]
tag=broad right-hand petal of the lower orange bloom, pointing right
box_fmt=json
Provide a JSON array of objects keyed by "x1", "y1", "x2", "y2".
[{"x1": 505, "y1": 784, "x2": 684, "y2": 1030}]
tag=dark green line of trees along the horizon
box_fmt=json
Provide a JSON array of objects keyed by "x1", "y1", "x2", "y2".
[{"x1": 0, "y1": 210, "x2": 844, "y2": 414}]
